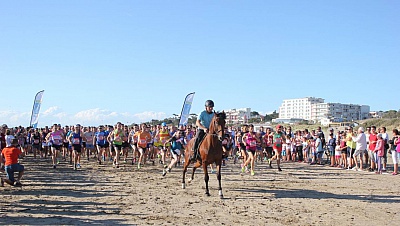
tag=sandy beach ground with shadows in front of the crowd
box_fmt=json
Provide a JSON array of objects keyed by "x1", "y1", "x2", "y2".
[{"x1": 0, "y1": 156, "x2": 400, "y2": 225}]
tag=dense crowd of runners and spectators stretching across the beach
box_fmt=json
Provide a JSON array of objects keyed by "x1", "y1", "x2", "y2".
[{"x1": 0, "y1": 122, "x2": 400, "y2": 185}]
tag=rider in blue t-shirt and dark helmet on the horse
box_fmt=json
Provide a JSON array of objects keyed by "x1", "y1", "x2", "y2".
[{"x1": 190, "y1": 100, "x2": 214, "y2": 161}]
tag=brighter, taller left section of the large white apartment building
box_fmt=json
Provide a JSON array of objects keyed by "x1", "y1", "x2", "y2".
[{"x1": 279, "y1": 97, "x2": 324, "y2": 120}]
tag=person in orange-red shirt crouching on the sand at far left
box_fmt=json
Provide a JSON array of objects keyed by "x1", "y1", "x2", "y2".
[{"x1": 0, "y1": 139, "x2": 24, "y2": 187}]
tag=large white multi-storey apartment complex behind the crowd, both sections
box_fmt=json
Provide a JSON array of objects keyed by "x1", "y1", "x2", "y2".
[{"x1": 279, "y1": 97, "x2": 370, "y2": 122}]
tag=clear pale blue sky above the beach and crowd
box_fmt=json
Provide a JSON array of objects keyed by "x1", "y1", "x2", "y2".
[{"x1": 0, "y1": 0, "x2": 400, "y2": 126}]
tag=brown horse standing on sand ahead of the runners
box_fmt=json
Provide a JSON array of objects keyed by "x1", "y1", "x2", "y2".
[{"x1": 182, "y1": 112, "x2": 226, "y2": 198}]
